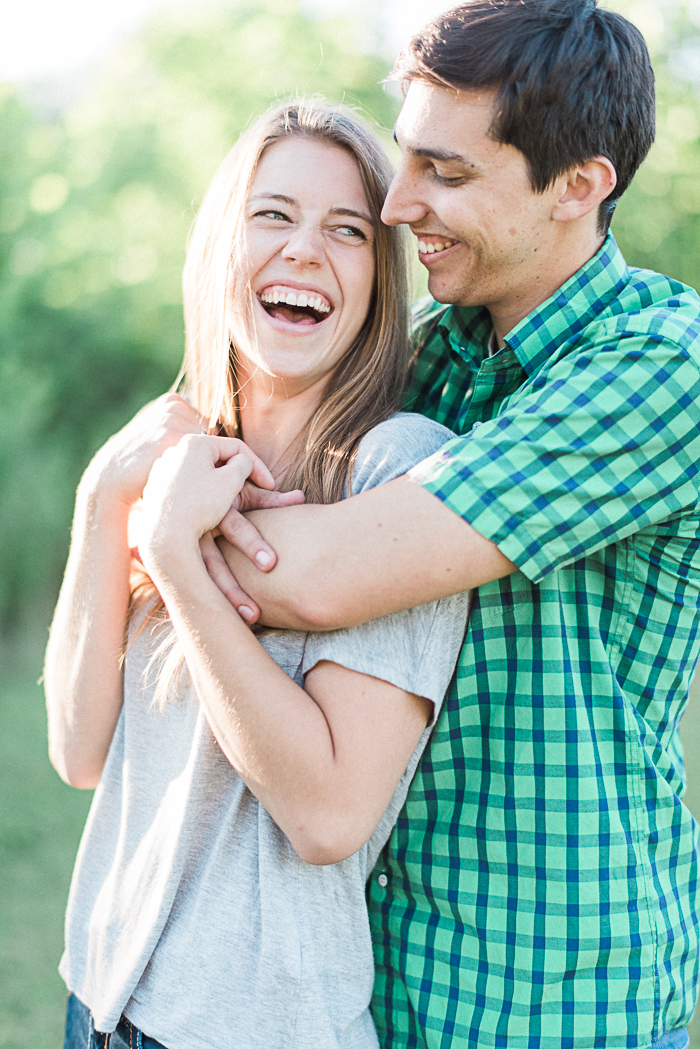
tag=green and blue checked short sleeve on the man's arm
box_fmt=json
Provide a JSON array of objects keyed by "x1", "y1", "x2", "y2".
[{"x1": 410, "y1": 319, "x2": 700, "y2": 582}]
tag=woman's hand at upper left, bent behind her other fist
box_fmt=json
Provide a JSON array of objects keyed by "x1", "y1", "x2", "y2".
[{"x1": 85, "y1": 393, "x2": 201, "y2": 507}]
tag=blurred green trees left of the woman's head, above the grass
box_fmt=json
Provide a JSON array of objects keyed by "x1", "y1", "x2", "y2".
[{"x1": 0, "y1": 0, "x2": 398, "y2": 627}]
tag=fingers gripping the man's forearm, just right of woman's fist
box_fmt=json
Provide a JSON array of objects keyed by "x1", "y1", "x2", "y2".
[{"x1": 199, "y1": 481, "x2": 304, "y2": 624}]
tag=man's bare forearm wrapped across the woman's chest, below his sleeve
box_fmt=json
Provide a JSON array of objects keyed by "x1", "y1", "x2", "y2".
[{"x1": 221, "y1": 477, "x2": 515, "y2": 630}]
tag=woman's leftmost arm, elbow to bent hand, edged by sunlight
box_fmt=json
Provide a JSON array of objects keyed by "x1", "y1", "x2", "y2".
[{"x1": 44, "y1": 393, "x2": 210, "y2": 789}]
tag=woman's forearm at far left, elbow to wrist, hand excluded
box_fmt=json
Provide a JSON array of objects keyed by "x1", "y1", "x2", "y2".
[{"x1": 44, "y1": 471, "x2": 131, "y2": 789}]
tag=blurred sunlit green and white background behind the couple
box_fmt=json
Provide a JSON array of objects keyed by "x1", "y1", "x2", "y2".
[{"x1": 0, "y1": 0, "x2": 700, "y2": 1049}]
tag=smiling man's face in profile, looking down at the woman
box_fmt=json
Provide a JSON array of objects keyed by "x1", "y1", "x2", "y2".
[{"x1": 382, "y1": 81, "x2": 561, "y2": 311}]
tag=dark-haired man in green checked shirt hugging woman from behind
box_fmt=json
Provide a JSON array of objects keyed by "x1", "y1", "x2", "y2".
[{"x1": 212, "y1": 0, "x2": 700, "y2": 1049}]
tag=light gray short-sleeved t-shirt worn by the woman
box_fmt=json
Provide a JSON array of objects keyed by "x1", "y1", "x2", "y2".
[{"x1": 60, "y1": 414, "x2": 468, "y2": 1049}]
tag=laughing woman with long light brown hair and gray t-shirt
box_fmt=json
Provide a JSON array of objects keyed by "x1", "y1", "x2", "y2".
[{"x1": 45, "y1": 101, "x2": 467, "y2": 1049}]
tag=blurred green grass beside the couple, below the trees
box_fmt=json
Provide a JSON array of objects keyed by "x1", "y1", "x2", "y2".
[{"x1": 0, "y1": 641, "x2": 700, "y2": 1049}]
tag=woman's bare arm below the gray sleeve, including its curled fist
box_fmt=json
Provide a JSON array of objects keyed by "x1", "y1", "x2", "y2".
[{"x1": 141, "y1": 437, "x2": 438, "y2": 863}]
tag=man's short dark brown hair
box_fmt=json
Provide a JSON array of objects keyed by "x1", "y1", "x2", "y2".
[{"x1": 390, "y1": 0, "x2": 655, "y2": 233}]
